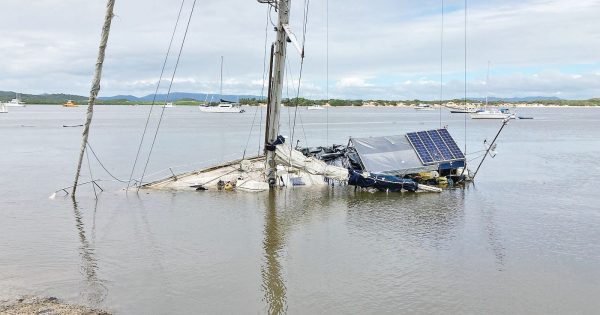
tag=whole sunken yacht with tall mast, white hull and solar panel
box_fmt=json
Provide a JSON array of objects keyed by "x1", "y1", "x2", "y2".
[{"x1": 138, "y1": 0, "x2": 478, "y2": 192}]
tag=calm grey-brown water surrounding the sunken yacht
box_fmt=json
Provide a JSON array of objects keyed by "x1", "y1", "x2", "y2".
[{"x1": 0, "y1": 106, "x2": 600, "y2": 314}]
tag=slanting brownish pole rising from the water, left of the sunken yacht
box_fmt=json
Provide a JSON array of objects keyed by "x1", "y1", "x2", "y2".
[{"x1": 72, "y1": 0, "x2": 115, "y2": 197}]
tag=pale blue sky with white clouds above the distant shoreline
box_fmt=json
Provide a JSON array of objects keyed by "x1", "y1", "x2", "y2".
[{"x1": 0, "y1": 0, "x2": 600, "y2": 100}]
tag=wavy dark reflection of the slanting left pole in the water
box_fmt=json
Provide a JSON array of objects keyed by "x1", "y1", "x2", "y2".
[{"x1": 72, "y1": 199, "x2": 108, "y2": 306}]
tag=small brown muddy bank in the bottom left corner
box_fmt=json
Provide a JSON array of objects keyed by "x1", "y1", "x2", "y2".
[{"x1": 0, "y1": 296, "x2": 110, "y2": 315}]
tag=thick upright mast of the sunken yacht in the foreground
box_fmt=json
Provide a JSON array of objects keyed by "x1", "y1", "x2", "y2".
[{"x1": 258, "y1": 0, "x2": 291, "y2": 188}]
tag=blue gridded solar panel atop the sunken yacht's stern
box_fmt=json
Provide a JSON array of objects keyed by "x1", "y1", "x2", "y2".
[{"x1": 406, "y1": 129, "x2": 465, "y2": 165}]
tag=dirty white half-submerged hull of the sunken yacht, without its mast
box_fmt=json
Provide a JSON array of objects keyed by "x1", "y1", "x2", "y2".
[{"x1": 141, "y1": 145, "x2": 441, "y2": 192}]
